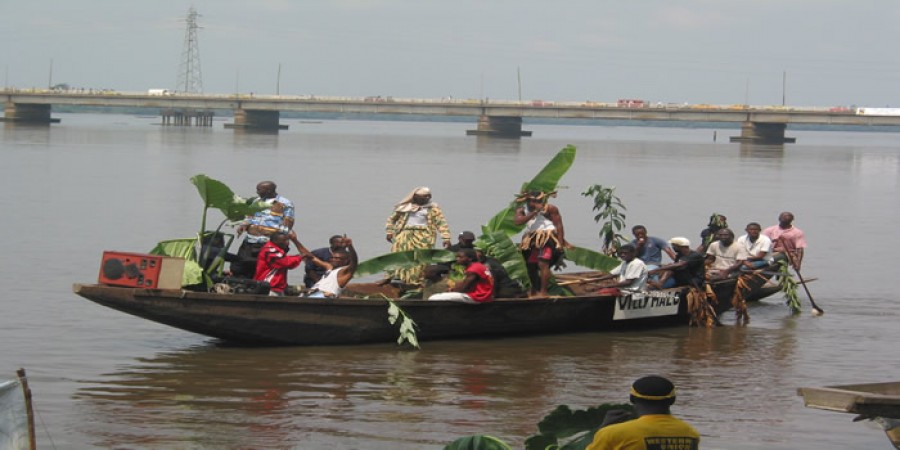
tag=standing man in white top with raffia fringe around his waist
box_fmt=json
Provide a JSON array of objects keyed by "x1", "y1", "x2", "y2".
[{"x1": 514, "y1": 191, "x2": 571, "y2": 298}]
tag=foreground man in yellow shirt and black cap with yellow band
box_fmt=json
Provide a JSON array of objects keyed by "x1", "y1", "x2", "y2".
[{"x1": 586, "y1": 375, "x2": 700, "y2": 450}]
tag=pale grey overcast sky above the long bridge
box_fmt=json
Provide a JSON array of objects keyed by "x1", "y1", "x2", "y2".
[{"x1": 0, "y1": 0, "x2": 900, "y2": 106}]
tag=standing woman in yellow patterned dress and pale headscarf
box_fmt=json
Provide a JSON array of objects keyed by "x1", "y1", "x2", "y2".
[{"x1": 385, "y1": 186, "x2": 450, "y2": 284}]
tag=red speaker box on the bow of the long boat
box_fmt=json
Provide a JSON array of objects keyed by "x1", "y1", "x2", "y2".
[{"x1": 97, "y1": 251, "x2": 184, "y2": 289}]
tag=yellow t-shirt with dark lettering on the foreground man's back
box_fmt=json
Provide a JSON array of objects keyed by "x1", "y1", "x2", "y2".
[{"x1": 586, "y1": 414, "x2": 700, "y2": 450}]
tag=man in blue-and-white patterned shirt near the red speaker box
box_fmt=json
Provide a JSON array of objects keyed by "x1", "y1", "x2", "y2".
[{"x1": 231, "y1": 181, "x2": 294, "y2": 278}]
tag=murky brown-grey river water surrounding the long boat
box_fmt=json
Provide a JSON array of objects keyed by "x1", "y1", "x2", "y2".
[{"x1": 0, "y1": 114, "x2": 900, "y2": 449}]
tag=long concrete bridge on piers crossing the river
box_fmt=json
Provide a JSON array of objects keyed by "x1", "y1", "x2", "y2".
[{"x1": 0, "y1": 89, "x2": 900, "y2": 144}]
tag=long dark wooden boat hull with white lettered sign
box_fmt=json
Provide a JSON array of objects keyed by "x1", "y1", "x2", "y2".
[{"x1": 73, "y1": 272, "x2": 778, "y2": 345}]
